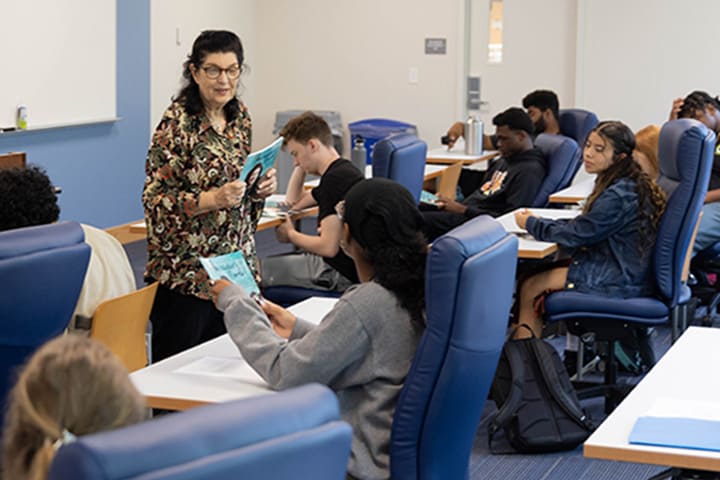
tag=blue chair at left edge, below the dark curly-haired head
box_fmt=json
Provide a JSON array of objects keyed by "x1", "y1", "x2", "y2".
[{"x1": 0, "y1": 222, "x2": 90, "y2": 420}]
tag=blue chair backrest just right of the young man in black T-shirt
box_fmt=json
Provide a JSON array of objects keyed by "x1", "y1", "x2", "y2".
[{"x1": 372, "y1": 133, "x2": 427, "y2": 202}]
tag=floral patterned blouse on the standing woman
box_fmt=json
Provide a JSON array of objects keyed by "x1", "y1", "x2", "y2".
[{"x1": 142, "y1": 102, "x2": 264, "y2": 299}]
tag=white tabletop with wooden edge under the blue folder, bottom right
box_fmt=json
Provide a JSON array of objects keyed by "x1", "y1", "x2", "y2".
[{"x1": 584, "y1": 327, "x2": 720, "y2": 471}]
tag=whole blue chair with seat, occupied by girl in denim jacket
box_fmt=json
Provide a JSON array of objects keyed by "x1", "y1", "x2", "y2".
[{"x1": 545, "y1": 119, "x2": 715, "y2": 411}]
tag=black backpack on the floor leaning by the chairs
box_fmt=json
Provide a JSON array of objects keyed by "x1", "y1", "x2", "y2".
[{"x1": 488, "y1": 325, "x2": 595, "y2": 453}]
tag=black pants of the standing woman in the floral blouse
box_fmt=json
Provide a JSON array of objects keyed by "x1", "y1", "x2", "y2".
[{"x1": 150, "y1": 285, "x2": 227, "y2": 362}]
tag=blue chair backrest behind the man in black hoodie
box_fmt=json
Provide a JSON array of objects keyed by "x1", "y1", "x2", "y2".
[{"x1": 531, "y1": 133, "x2": 578, "y2": 207}]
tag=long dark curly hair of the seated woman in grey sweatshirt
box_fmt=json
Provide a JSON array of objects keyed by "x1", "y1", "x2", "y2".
[{"x1": 343, "y1": 178, "x2": 427, "y2": 328}]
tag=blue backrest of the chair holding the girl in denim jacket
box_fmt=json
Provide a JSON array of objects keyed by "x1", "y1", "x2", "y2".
[{"x1": 654, "y1": 119, "x2": 715, "y2": 307}]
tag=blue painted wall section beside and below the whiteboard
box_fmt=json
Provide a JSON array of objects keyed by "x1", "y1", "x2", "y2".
[{"x1": 0, "y1": 0, "x2": 150, "y2": 228}]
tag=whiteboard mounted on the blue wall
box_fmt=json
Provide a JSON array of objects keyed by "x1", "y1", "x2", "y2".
[{"x1": 0, "y1": 0, "x2": 116, "y2": 128}]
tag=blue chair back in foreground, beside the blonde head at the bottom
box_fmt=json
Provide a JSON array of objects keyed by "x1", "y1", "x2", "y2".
[{"x1": 48, "y1": 384, "x2": 352, "y2": 480}]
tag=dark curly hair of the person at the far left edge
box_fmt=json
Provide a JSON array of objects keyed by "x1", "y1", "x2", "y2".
[{"x1": 0, "y1": 166, "x2": 60, "y2": 231}]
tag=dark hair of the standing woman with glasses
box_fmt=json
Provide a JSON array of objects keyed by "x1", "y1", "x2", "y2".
[{"x1": 176, "y1": 30, "x2": 246, "y2": 122}]
